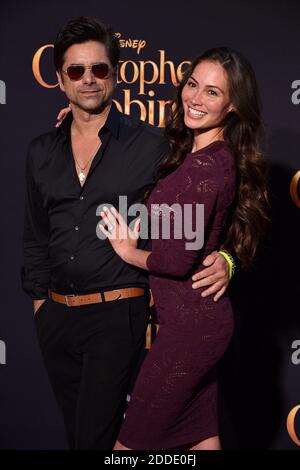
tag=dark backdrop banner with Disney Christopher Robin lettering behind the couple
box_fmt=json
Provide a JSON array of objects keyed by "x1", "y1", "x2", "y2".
[{"x1": 0, "y1": 0, "x2": 300, "y2": 449}]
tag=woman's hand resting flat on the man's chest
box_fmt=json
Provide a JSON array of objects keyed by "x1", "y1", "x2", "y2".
[{"x1": 100, "y1": 207, "x2": 140, "y2": 261}]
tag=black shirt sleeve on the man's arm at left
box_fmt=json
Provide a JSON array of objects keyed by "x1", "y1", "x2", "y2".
[{"x1": 21, "y1": 143, "x2": 50, "y2": 300}]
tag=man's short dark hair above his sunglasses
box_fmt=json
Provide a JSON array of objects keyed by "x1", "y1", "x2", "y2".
[{"x1": 54, "y1": 16, "x2": 120, "y2": 71}]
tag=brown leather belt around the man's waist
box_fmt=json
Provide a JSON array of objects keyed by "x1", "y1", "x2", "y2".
[{"x1": 49, "y1": 287, "x2": 145, "y2": 307}]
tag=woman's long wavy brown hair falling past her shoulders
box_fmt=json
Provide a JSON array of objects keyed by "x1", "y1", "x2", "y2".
[{"x1": 151, "y1": 47, "x2": 269, "y2": 268}]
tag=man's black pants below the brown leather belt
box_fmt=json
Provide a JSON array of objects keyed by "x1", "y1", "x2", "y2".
[{"x1": 35, "y1": 293, "x2": 149, "y2": 450}]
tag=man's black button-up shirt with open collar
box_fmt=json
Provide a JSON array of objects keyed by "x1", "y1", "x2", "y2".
[{"x1": 22, "y1": 105, "x2": 168, "y2": 299}]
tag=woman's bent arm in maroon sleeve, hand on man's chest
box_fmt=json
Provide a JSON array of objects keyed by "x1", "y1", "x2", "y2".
[{"x1": 101, "y1": 152, "x2": 220, "y2": 278}]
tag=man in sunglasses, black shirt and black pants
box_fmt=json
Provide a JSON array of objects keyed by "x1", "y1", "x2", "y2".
[{"x1": 23, "y1": 17, "x2": 232, "y2": 449}]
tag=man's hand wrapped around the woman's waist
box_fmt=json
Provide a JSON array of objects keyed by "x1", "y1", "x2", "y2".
[{"x1": 192, "y1": 251, "x2": 229, "y2": 302}]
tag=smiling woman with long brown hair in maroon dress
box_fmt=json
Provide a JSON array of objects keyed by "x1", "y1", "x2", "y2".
[{"x1": 101, "y1": 47, "x2": 267, "y2": 450}]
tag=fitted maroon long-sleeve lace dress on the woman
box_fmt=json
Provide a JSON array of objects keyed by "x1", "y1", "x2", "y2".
[{"x1": 119, "y1": 141, "x2": 236, "y2": 450}]
